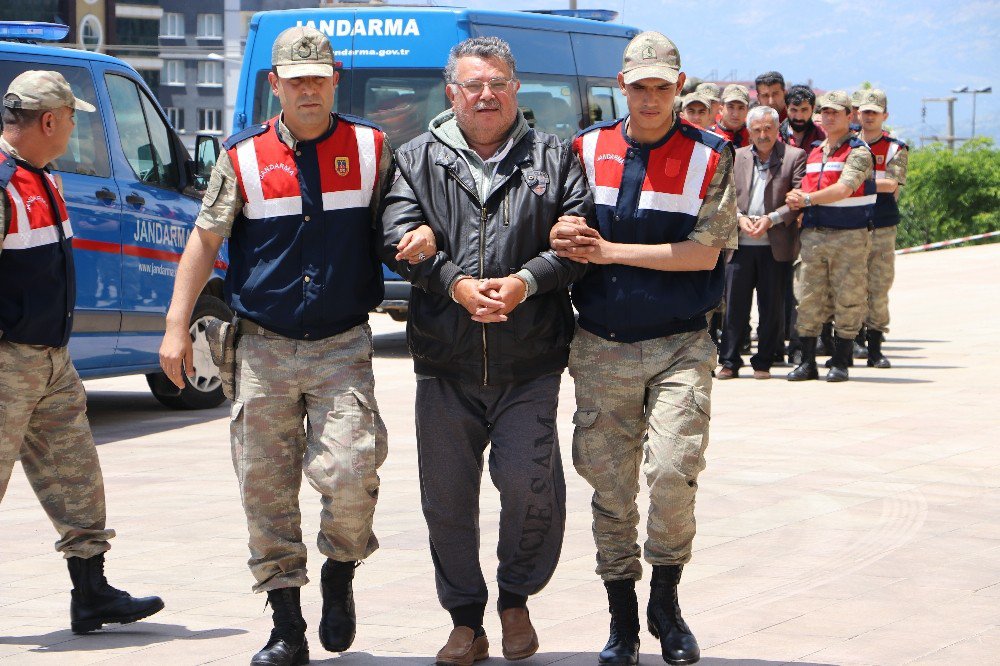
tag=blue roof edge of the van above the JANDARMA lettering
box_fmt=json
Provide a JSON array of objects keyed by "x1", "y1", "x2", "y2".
[{"x1": 250, "y1": 5, "x2": 639, "y2": 37}]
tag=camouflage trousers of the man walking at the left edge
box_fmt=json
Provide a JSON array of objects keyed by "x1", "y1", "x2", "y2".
[{"x1": 0, "y1": 340, "x2": 115, "y2": 559}]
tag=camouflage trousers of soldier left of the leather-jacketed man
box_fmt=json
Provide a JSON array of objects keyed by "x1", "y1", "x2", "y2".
[{"x1": 230, "y1": 324, "x2": 387, "y2": 592}]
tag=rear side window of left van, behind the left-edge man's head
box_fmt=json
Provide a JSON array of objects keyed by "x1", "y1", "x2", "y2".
[{"x1": 0, "y1": 60, "x2": 111, "y2": 178}]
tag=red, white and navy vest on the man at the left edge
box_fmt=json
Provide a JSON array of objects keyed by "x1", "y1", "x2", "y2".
[{"x1": 0, "y1": 152, "x2": 76, "y2": 347}]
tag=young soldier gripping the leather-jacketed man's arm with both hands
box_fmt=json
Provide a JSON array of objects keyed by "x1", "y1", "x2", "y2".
[{"x1": 550, "y1": 32, "x2": 738, "y2": 664}]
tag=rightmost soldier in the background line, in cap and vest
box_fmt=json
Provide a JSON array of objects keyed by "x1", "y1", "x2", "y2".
[{"x1": 858, "y1": 89, "x2": 909, "y2": 368}]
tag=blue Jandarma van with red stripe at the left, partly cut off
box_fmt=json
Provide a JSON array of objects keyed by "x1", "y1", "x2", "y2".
[{"x1": 0, "y1": 22, "x2": 231, "y2": 408}]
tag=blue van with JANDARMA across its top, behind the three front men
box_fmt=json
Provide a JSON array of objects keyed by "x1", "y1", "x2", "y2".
[{"x1": 233, "y1": 7, "x2": 639, "y2": 319}]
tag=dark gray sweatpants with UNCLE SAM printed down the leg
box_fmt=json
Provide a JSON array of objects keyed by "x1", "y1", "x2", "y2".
[{"x1": 416, "y1": 375, "x2": 566, "y2": 610}]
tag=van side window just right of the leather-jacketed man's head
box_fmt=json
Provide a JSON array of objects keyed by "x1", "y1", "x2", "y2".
[{"x1": 517, "y1": 73, "x2": 586, "y2": 140}]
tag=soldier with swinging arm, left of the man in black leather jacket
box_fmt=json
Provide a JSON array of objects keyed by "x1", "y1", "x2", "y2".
[{"x1": 160, "y1": 27, "x2": 434, "y2": 664}]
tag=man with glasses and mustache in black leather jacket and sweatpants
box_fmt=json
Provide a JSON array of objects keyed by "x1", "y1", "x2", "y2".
[{"x1": 383, "y1": 37, "x2": 593, "y2": 664}]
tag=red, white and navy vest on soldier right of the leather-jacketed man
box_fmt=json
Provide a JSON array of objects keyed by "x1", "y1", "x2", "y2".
[{"x1": 573, "y1": 115, "x2": 732, "y2": 342}]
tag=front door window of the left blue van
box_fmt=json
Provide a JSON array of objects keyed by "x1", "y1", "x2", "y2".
[{"x1": 105, "y1": 74, "x2": 180, "y2": 187}]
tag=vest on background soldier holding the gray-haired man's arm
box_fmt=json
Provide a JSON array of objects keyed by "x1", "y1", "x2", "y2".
[{"x1": 801, "y1": 137, "x2": 875, "y2": 229}]
